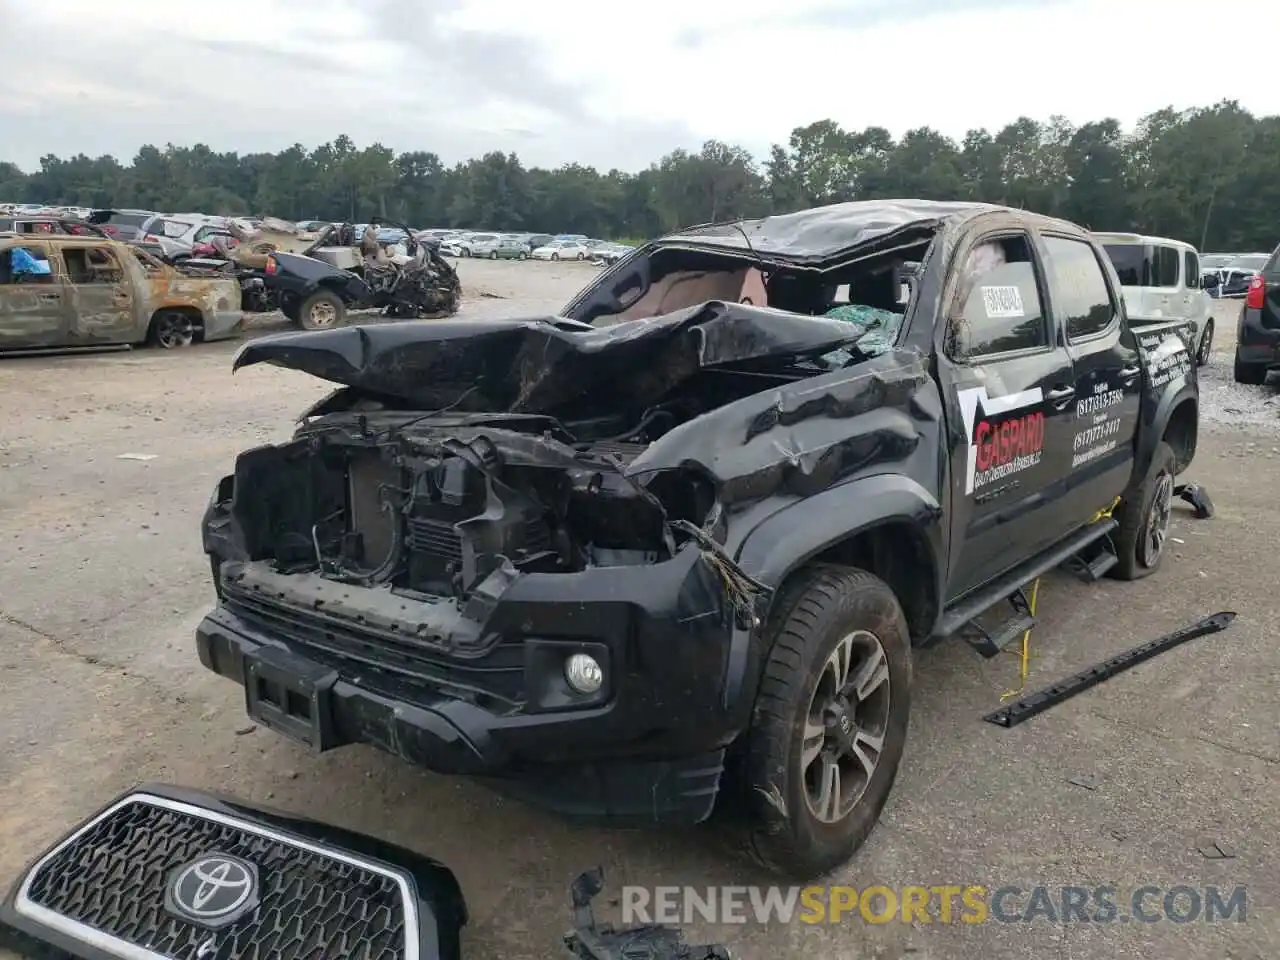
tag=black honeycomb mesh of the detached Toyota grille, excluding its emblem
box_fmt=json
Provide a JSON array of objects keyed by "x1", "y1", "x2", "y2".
[{"x1": 27, "y1": 799, "x2": 406, "y2": 960}]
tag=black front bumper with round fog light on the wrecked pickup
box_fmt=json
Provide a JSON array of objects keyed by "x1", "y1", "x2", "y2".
[{"x1": 196, "y1": 550, "x2": 750, "y2": 823}]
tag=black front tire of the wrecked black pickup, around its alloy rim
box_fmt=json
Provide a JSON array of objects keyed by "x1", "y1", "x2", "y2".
[{"x1": 741, "y1": 567, "x2": 911, "y2": 882}]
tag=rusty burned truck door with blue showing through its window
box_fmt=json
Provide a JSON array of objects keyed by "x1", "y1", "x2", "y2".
[{"x1": 0, "y1": 241, "x2": 70, "y2": 349}]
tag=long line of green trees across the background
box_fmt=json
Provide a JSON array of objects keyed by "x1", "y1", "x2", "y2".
[{"x1": 0, "y1": 101, "x2": 1280, "y2": 251}]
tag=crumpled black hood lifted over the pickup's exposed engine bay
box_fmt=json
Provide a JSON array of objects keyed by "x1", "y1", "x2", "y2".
[{"x1": 233, "y1": 302, "x2": 864, "y2": 413}]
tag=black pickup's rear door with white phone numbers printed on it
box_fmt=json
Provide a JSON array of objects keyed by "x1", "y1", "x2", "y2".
[{"x1": 1042, "y1": 234, "x2": 1141, "y2": 524}]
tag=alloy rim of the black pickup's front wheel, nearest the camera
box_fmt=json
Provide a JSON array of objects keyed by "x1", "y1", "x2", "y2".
[{"x1": 800, "y1": 630, "x2": 891, "y2": 823}]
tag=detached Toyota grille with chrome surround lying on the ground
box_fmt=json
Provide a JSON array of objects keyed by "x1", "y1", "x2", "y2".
[{"x1": 0, "y1": 785, "x2": 467, "y2": 960}]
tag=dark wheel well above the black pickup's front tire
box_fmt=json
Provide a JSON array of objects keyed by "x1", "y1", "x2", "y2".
[{"x1": 792, "y1": 521, "x2": 938, "y2": 643}]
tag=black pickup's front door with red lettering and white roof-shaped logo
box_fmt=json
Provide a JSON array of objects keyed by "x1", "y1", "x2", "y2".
[{"x1": 938, "y1": 232, "x2": 1075, "y2": 600}]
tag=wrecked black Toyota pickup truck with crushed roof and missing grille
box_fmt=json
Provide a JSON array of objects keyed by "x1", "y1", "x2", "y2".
[{"x1": 196, "y1": 201, "x2": 1198, "y2": 878}]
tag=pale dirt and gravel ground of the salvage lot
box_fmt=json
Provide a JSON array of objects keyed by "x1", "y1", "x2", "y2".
[{"x1": 0, "y1": 262, "x2": 1280, "y2": 960}]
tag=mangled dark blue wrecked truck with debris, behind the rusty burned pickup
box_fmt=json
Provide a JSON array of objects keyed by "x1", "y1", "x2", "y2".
[{"x1": 183, "y1": 219, "x2": 462, "y2": 330}]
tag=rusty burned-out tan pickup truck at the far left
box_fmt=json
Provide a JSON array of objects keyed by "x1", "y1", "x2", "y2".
[{"x1": 0, "y1": 231, "x2": 244, "y2": 351}]
